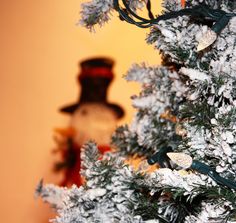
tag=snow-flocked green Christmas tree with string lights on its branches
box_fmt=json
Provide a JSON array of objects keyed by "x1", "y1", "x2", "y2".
[{"x1": 37, "y1": 0, "x2": 236, "y2": 223}]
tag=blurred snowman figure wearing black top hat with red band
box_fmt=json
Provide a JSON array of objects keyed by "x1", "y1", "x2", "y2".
[{"x1": 52, "y1": 57, "x2": 124, "y2": 186}]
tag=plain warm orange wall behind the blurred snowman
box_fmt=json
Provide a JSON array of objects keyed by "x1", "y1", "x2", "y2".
[{"x1": 0, "y1": 0, "x2": 160, "y2": 223}]
